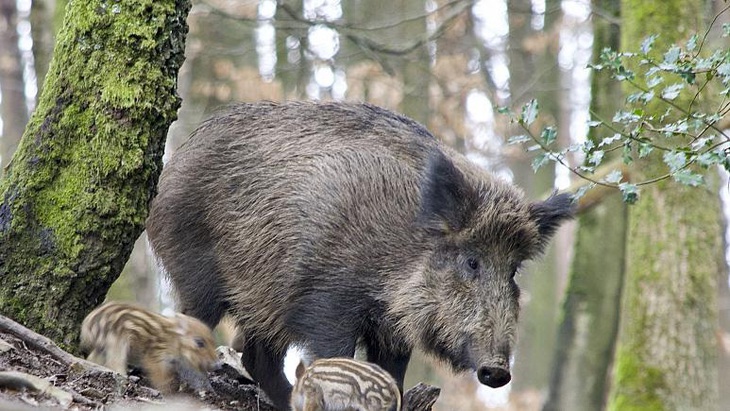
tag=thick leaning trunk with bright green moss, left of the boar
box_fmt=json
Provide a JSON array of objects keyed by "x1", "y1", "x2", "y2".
[{"x1": 0, "y1": 0, "x2": 190, "y2": 348}]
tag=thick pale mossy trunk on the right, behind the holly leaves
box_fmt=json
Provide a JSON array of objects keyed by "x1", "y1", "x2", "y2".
[{"x1": 608, "y1": 0, "x2": 724, "y2": 410}]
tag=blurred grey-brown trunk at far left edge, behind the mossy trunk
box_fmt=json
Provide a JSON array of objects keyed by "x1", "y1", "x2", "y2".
[{"x1": 0, "y1": 0, "x2": 28, "y2": 171}]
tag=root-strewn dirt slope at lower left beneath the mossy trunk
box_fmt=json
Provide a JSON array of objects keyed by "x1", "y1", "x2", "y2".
[{"x1": 0, "y1": 331, "x2": 274, "y2": 411}]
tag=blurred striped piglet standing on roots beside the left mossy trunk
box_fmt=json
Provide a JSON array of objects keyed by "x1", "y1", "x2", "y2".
[{"x1": 81, "y1": 302, "x2": 217, "y2": 393}]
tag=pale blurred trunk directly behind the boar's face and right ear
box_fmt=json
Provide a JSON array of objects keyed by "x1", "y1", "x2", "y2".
[{"x1": 508, "y1": 0, "x2": 568, "y2": 391}]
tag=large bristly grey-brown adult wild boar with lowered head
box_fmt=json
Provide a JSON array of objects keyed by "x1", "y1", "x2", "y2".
[{"x1": 147, "y1": 102, "x2": 572, "y2": 409}]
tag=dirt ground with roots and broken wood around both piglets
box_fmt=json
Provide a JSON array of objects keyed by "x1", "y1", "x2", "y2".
[{"x1": 0, "y1": 315, "x2": 441, "y2": 411}]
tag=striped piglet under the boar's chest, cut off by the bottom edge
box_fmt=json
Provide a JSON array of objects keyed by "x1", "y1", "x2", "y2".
[{"x1": 291, "y1": 358, "x2": 401, "y2": 411}]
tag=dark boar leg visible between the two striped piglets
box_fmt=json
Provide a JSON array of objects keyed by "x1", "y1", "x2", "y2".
[{"x1": 239, "y1": 337, "x2": 292, "y2": 410}]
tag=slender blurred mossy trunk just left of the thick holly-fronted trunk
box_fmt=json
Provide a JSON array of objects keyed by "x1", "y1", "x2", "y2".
[{"x1": 543, "y1": 0, "x2": 627, "y2": 411}]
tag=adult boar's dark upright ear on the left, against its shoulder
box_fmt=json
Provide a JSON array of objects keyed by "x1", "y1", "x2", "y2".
[{"x1": 419, "y1": 152, "x2": 478, "y2": 234}]
